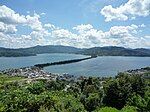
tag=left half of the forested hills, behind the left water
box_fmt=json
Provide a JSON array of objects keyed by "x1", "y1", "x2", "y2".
[{"x1": 0, "y1": 45, "x2": 82, "y2": 57}]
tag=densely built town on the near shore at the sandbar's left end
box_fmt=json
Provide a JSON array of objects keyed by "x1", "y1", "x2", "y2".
[{"x1": 0, "y1": 66, "x2": 81, "y2": 81}]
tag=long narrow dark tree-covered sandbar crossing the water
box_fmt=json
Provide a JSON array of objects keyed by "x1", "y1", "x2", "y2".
[{"x1": 34, "y1": 56, "x2": 97, "y2": 68}]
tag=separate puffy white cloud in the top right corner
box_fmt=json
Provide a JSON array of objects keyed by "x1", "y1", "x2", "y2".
[{"x1": 101, "y1": 0, "x2": 150, "y2": 22}]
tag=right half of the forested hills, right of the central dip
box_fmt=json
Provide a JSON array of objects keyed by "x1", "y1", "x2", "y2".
[{"x1": 79, "y1": 46, "x2": 150, "y2": 57}]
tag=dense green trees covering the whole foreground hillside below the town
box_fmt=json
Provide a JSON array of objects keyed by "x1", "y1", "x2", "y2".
[{"x1": 0, "y1": 73, "x2": 150, "y2": 112}]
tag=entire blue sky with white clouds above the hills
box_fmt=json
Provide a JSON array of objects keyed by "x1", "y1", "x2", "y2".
[{"x1": 0, "y1": 0, "x2": 150, "y2": 48}]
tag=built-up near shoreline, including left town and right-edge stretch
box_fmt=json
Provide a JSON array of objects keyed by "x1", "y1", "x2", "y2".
[{"x1": 0, "y1": 66, "x2": 150, "y2": 81}]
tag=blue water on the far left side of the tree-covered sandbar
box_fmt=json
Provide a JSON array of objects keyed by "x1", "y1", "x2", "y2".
[{"x1": 0, "y1": 53, "x2": 85, "y2": 70}]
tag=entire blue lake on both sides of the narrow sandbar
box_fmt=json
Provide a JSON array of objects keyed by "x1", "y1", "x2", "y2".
[{"x1": 0, "y1": 53, "x2": 150, "y2": 76}]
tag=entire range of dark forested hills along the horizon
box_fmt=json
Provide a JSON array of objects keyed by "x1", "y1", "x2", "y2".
[{"x1": 0, "y1": 45, "x2": 150, "y2": 57}]
